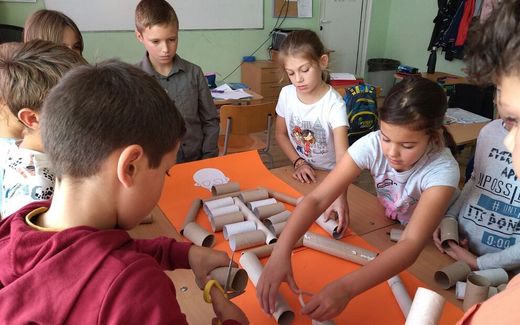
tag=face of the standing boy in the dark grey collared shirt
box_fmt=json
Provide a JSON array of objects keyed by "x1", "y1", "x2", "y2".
[{"x1": 136, "y1": 24, "x2": 179, "y2": 67}]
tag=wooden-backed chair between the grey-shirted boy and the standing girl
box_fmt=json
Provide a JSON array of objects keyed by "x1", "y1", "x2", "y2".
[{"x1": 219, "y1": 102, "x2": 276, "y2": 168}]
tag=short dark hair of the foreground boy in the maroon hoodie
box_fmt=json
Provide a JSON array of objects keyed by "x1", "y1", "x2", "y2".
[{"x1": 41, "y1": 60, "x2": 186, "y2": 179}]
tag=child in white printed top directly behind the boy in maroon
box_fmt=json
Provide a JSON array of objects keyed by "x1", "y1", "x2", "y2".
[{"x1": 0, "y1": 40, "x2": 86, "y2": 218}]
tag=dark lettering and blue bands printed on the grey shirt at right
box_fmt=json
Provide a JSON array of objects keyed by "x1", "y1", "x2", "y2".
[{"x1": 463, "y1": 148, "x2": 520, "y2": 249}]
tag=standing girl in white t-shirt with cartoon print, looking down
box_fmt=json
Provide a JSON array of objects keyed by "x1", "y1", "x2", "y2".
[{"x1": 276, "y1": 30, "x2": 348, "y2": 231}]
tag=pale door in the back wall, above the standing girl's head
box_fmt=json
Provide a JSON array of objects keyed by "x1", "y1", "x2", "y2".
[{"x1": 320, "y1": 0, "x2": 366, "y2": 75}]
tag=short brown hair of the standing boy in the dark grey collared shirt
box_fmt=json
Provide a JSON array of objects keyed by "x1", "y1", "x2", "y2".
[{"x1": 135, "y1": 0, "x2": 179, "y2": 33}]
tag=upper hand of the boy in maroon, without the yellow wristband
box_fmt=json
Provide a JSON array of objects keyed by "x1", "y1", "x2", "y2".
[{"x1": 188, "y1": 245, "x2": 236, "y2": 289}]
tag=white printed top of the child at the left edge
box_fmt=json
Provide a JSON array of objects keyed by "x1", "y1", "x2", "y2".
[{"x1": 0, "y1": 145, "x2": 55, "y2": 218}]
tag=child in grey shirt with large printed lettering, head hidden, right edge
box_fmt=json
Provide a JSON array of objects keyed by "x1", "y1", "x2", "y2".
[{"x1": 433, "y1": 115, "x2": 520, "y2": 273}]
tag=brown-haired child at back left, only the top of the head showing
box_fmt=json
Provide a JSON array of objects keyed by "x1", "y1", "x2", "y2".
[{"x1": 23, "y1": 9, "x2": 83, "y2": 55}]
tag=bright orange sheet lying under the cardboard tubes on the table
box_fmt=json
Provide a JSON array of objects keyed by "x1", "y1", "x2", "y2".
[{"x1": 159, "y1": 151, "x2": 463, "y2": 324}]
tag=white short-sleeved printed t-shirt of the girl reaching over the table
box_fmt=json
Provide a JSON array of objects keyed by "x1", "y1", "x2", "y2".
[{"x1": 348, "y1": 131, "x2": 460, "y2": 224}]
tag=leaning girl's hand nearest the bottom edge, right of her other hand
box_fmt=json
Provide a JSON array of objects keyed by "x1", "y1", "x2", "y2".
[{"x1": 302, "y1": 280, "x2": 351, "y2": 321}]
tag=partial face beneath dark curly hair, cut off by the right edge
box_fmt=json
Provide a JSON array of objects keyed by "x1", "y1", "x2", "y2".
[{"x1": 497, "y1": 76, "x2": 520, "y2": 175}]
